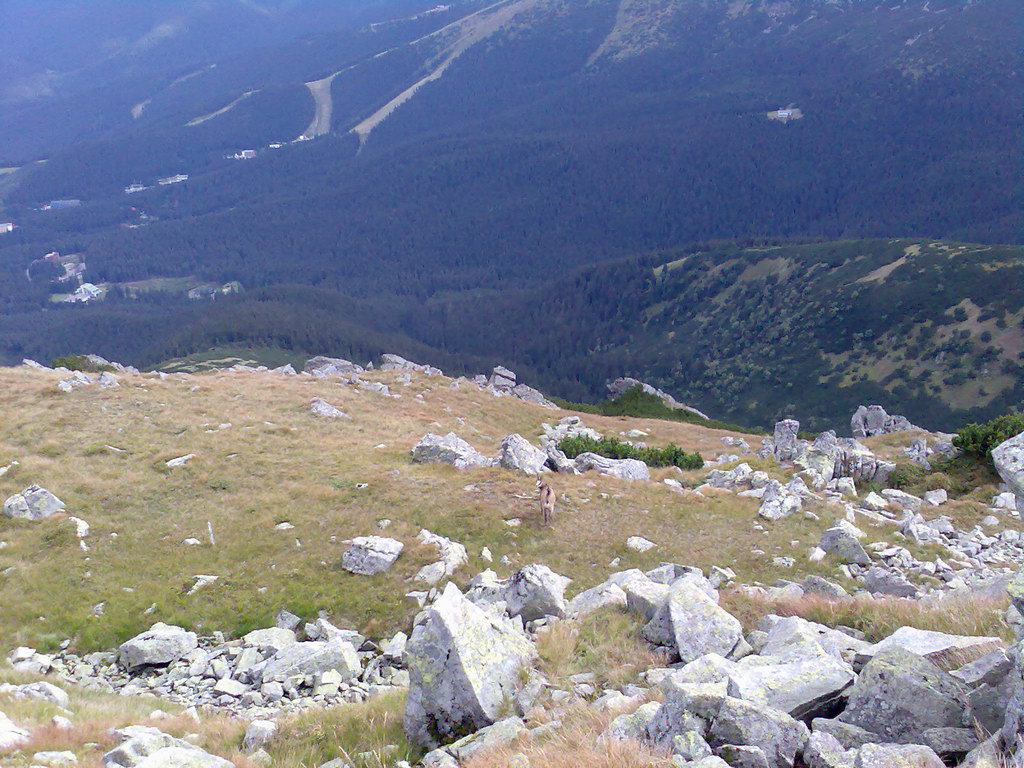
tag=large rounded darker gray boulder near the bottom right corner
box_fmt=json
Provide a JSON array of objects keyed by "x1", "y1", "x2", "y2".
[{"x1": 838, "y1": 648, "x2": 970, "y2": 743}]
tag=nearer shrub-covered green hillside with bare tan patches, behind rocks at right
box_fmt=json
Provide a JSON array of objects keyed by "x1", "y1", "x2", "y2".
[{"x1": 423, "y1": 241, "x2": 1024, "y2": 428}]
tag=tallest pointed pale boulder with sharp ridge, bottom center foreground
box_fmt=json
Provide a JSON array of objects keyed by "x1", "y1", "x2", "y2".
[{"x1": 404, "y1": 584, "x2": 537, "y2": 749}]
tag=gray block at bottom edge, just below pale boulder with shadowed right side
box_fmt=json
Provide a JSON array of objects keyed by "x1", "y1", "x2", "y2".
[{"x1": 708, "y1": 696, "x2": 810, "y2": 768}]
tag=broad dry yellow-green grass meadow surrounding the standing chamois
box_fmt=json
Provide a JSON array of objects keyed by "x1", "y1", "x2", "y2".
[{"x1": 0, "y1": 369, "x2": 819, "y2": 650}]
